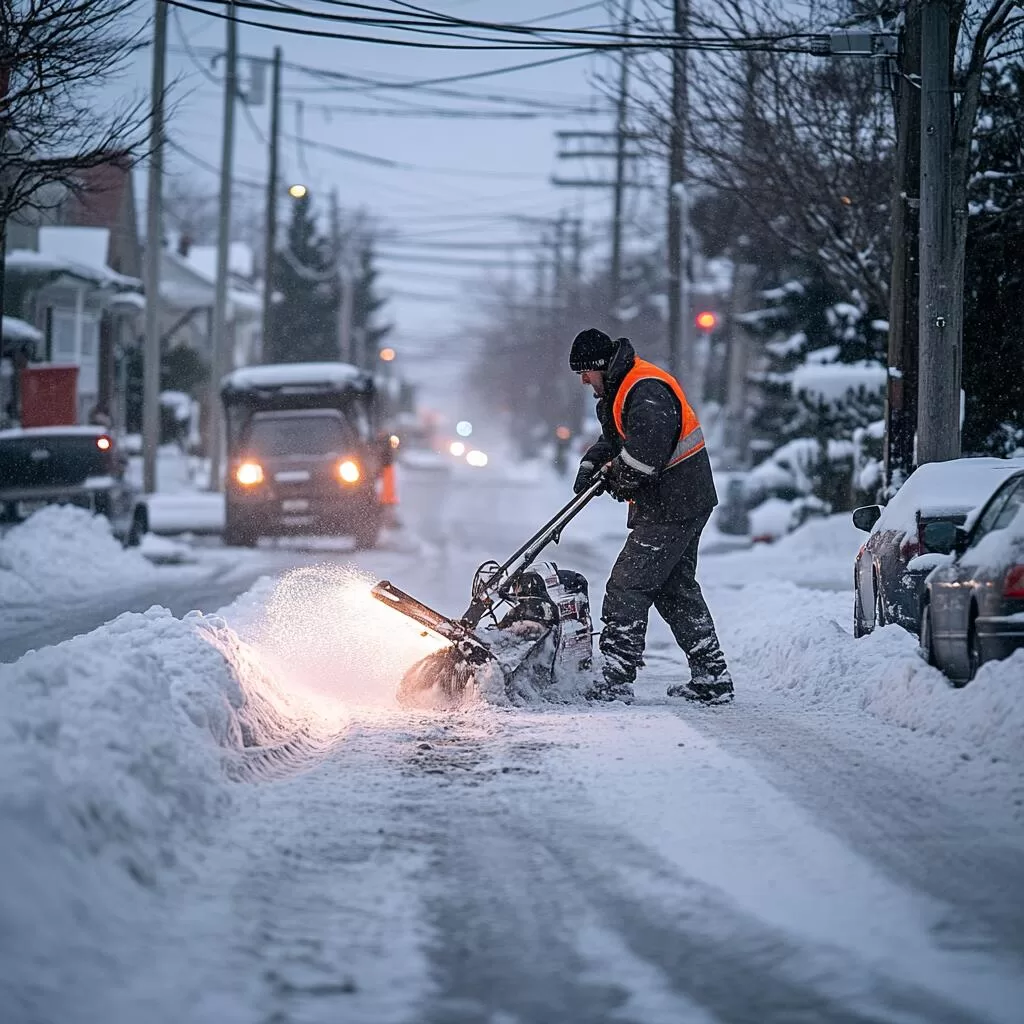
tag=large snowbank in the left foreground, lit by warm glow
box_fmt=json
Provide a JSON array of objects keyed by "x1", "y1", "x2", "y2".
[{"x1": 0, "y1": 607, "x2": 344, "y2": 1020}]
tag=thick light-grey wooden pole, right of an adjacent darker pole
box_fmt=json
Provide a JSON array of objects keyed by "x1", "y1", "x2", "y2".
[{"x1": 918, "y1": 0, "x2": 961, "y2": 465}]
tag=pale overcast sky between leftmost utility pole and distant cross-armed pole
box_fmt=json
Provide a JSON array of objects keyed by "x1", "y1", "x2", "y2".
[{"x1": 110, "y1": 0, "x2": 647, "y2": 401}]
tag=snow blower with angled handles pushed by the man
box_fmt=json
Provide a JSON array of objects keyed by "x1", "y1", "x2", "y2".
[{"x1": 373, "y1": 467, "x2": 606, "y2": 708}]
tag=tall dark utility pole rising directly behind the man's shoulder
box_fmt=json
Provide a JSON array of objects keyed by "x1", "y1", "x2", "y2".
[{"x1": 667, "y1": 0, "x2": 692, "y2": 380}]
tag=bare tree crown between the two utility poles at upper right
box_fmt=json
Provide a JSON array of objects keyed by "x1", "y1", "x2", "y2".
[{"x1": 641, "y1": 0, "x2": 895, "y2": 309}]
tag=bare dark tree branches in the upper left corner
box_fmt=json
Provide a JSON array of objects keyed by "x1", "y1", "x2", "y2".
[{"x1": 0, "y1": 0, "x2": 145, "y2": 308}]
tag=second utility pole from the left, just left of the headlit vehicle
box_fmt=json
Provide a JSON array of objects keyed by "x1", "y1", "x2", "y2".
[{"x1": 209, "y1": 0, "x2": 239, "y2": 490}]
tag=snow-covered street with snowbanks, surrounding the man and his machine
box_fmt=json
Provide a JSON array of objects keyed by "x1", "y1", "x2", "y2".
[{"x1": 0, "y1": 458, "x2": 1024, "y2": 1024}]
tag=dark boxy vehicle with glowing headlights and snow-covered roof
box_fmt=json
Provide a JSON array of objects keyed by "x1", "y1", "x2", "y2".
[{"x1": 221, "y1": 364, "x2": 385, "y2": 548}]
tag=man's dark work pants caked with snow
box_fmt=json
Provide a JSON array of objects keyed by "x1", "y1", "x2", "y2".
[{"x1": 600, "y1": 511, "x2": 726, "y2": 683}]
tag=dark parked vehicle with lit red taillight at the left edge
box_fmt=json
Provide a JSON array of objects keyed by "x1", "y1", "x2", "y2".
[{"x1": 0, "y1": 426, "x2": 144, "y2": 545}]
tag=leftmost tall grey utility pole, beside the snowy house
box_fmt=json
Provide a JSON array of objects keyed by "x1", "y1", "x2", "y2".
[{"x1": 143, "y1": 0, "x2": 167, "y2": 495}]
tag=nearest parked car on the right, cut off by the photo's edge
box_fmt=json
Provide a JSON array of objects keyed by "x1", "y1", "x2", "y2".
[{"x1": 921, "y1": 470, "x2": 1024, "y2": 684}]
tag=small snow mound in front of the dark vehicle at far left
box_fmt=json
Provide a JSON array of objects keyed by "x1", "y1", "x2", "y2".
[{"x1": 0, "y1": 505, "x2": 159, "y2": 605}]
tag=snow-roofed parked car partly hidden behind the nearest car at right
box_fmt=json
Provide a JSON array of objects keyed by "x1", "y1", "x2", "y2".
[{"x1": 853, "y1": 459, "x2": 1024, "y2": 637}]
